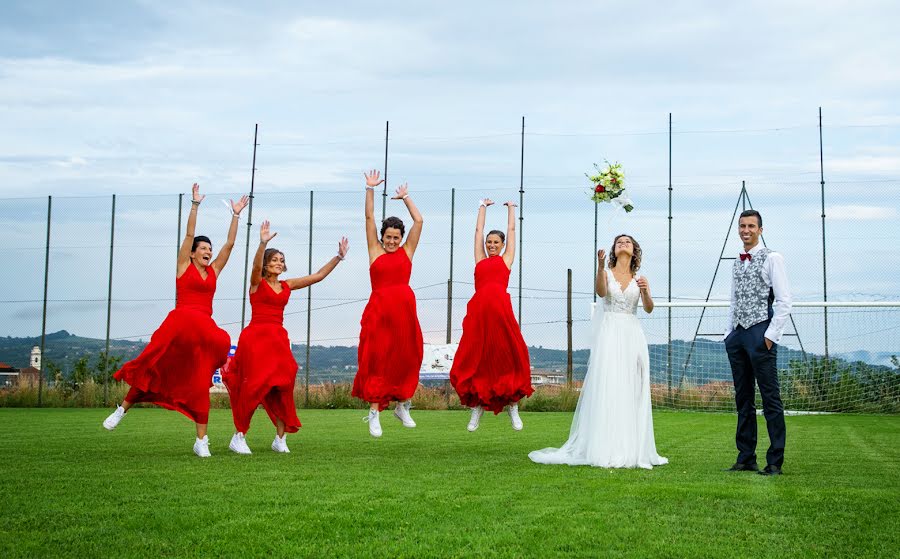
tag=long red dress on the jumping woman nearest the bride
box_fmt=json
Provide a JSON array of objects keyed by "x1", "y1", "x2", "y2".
[{"x1": 450, "y1": 256, "x2": 534, "y2": 414}]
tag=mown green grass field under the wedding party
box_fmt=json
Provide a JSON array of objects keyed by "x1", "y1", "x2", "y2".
[{"x1": 0, "y1": 409, "x2": 900, "y2": 557}]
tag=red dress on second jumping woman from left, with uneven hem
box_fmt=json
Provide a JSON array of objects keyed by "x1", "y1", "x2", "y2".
[{"x1": 222, "y1": 280, "x2": 300, "y2": 433}]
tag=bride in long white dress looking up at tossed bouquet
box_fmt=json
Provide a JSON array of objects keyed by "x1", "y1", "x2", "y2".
[{"x1": 528, "y1": 235, "x2": 669, "y2": 469}]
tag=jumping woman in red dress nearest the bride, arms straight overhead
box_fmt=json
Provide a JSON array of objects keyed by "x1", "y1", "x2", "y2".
[{"x1": 450, "y1": 200, "x2": 534, "y2": 431}]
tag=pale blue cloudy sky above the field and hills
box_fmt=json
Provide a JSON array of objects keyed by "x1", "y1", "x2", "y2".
[{"x1": 0, "y1": 1, "x2": 900, "y2": 351}]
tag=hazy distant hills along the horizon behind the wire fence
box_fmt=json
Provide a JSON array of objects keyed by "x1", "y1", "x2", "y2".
[{"x1": 0, "y1": 330, "x2": 890, "y2": 384}]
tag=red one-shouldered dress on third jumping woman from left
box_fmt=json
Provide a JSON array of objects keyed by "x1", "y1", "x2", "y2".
[{"x1": 353, "y1": 247, "x2": 423, "y2": 410}]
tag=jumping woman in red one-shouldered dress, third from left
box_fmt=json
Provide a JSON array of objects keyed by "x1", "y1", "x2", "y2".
[{"x1": 352, "y1": 170, "x2": 423, "y2": 437}]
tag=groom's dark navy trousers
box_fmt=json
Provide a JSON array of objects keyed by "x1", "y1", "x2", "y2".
[{"x1": 725, "y1": 320, "x2": 785, "y2": 466}]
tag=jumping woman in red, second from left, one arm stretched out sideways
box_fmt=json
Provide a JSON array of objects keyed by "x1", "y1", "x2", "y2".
[{"x1": 222, "y1": 221, "x2": 347, "y2": 454}]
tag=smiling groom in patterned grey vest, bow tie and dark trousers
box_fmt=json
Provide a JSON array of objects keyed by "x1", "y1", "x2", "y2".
[{"x1": 725, "y1": 210, "x2": 791, "y2": 476}]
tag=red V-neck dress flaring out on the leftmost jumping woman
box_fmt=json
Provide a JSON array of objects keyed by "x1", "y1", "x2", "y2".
[{"x1": 114, "y1": 263, "x2": 231, "y2": 424}]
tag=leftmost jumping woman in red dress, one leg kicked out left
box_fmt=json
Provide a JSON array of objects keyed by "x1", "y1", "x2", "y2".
[{"x1": 103, "y1": 183, "x2": 249, "y2": 458}]
